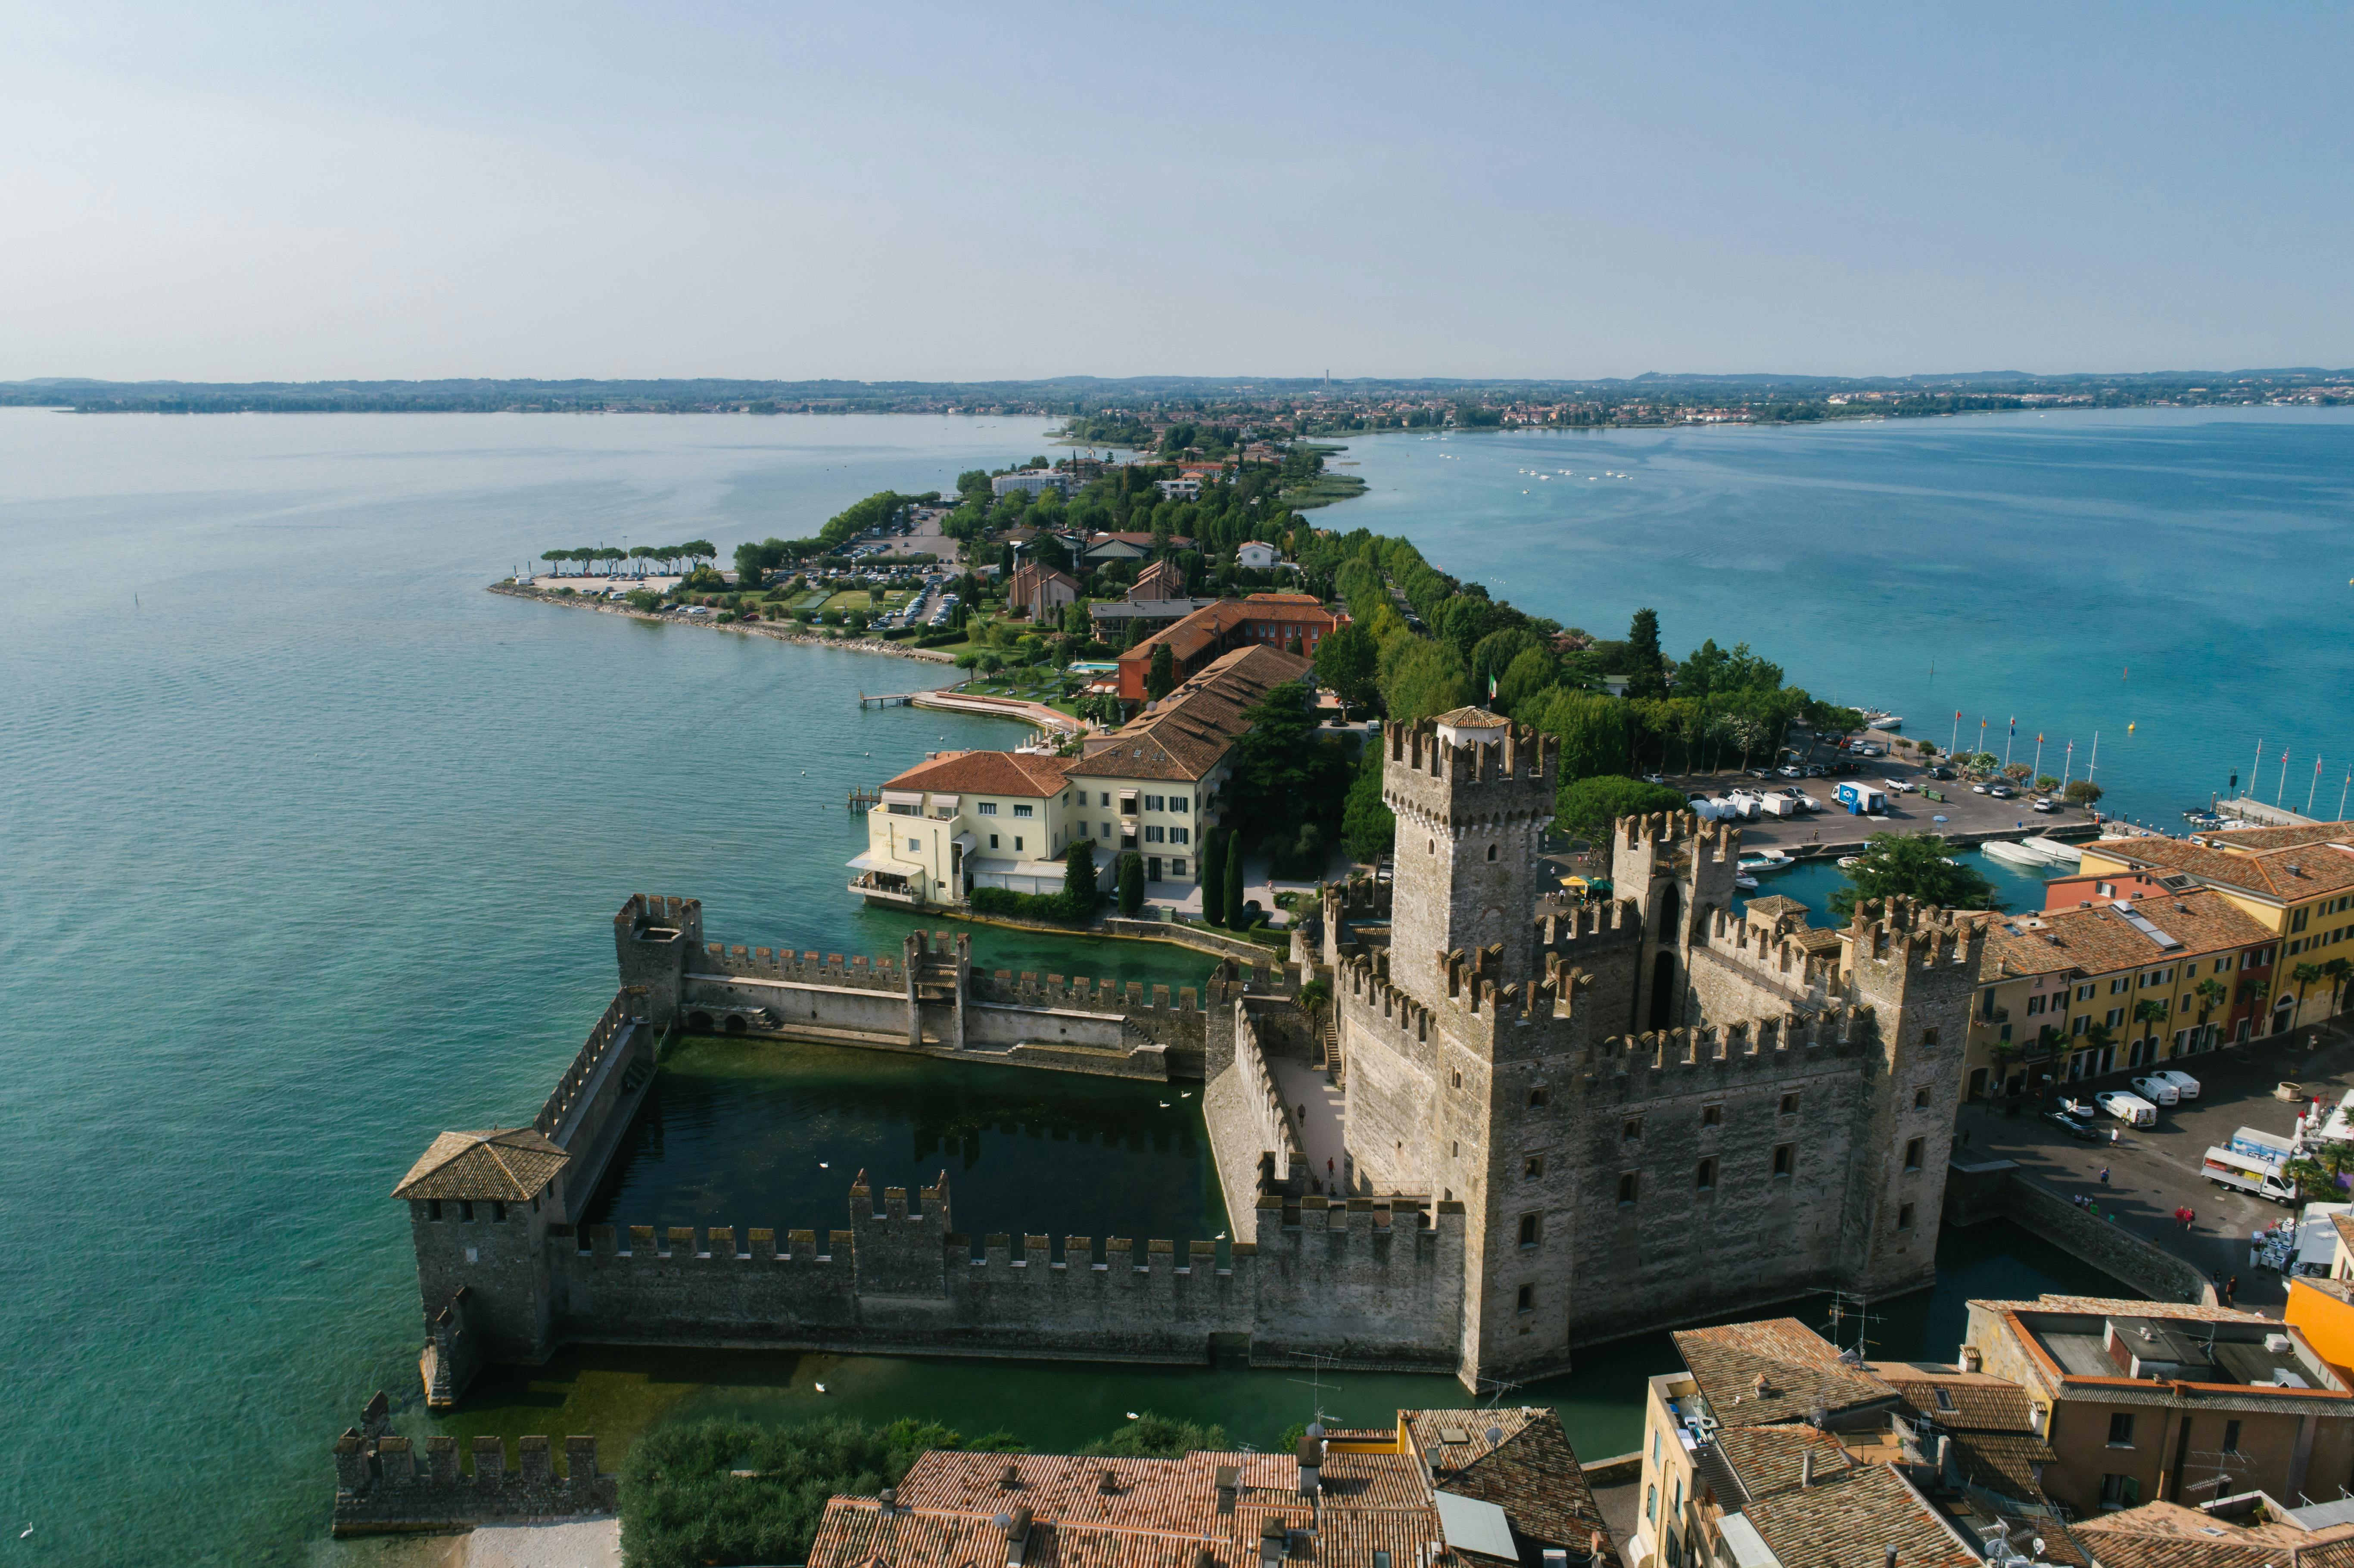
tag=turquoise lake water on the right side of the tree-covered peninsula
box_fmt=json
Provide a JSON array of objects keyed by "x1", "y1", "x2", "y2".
[{"x1": 1323, "y1": 410, "x2": 2354, "y2": 831}]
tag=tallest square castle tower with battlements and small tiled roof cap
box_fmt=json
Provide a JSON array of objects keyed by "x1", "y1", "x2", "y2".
[{"x1": 1382, "y1": 709, "x2": 1561, "y2": 998}]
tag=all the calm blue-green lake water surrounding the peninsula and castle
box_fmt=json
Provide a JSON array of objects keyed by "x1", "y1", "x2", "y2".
[{"x1": 0, "y1": 410, "x2": 2354, "y2": 1563}]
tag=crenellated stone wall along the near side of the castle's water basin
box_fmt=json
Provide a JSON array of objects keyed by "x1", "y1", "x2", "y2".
[{"x1": 433, "y1": 1177, "x2": 1462, "y2": 1368}]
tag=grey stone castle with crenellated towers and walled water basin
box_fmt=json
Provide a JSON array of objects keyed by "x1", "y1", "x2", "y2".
[{"x1": 393, "y1": 709, "x2": 1984, "y2": 1406}]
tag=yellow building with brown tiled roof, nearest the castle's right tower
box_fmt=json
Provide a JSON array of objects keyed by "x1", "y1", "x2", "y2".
[{"x1": 1963, "y1": 885, "x2": 2274, "y2": 1099}]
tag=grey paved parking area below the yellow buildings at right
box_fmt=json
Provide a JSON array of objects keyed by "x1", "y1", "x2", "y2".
[{"x1": 1954, "y1": 1022, "x2": 2354, "y2": 1311}]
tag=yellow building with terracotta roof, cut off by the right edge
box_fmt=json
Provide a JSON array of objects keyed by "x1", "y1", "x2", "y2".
[{"x1": 2083, "y1": 821, "x2": 2354, "y2": 1033}]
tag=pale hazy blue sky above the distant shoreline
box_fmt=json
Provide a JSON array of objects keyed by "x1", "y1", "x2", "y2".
[{"x1": 0, "y1": 0, "x2": 2354, "y2": 381}]
